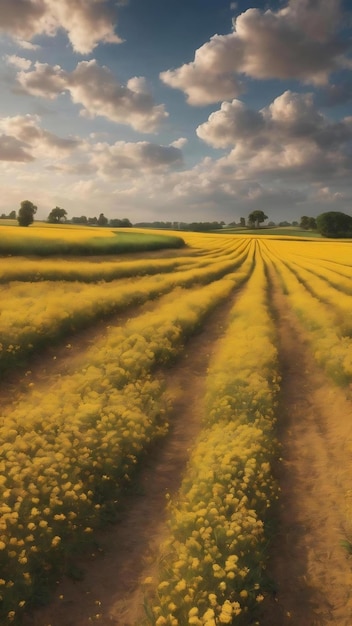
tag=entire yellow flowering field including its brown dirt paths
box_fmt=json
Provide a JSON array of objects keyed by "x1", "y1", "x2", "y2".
[{"x1": 0, "y1": 229, "x2": 352, "y2": 626}]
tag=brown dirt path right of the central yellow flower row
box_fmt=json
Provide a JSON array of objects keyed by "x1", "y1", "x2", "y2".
[{"x1": 260, "y1": 266, "x2": 352, "y2": 626}]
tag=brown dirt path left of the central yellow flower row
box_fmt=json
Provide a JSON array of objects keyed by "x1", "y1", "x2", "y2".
[{"x1": 24, "y1": 292, "x2": 233, "y2": 626}]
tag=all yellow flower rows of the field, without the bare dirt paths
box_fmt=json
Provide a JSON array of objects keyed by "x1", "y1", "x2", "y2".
[{"x1": 0, "y1": 227, "x2": 352, "y2": 626}]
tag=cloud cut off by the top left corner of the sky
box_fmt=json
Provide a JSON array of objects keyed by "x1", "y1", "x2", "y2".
[{"x1": 0, "y1": 0, "x2": 121, "y2": 54}]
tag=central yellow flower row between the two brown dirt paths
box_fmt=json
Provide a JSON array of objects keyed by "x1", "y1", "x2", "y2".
[{"x1": 145, "y1": 247, "x2": 279, "y2": 626}]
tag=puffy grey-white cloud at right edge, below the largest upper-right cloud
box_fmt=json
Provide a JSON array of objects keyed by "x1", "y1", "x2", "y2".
[{"x1": 197, "y1": 91, "x2": 352, "y2": 180}]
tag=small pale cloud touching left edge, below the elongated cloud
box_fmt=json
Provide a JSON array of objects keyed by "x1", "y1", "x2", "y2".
[{"x1": 0, "y1": 115, "x2": 81, "y2": 161}]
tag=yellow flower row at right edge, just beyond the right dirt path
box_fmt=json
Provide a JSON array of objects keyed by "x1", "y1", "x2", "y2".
[{"x1": 262, "y1": 243, "x2": 352, "y2": 385}]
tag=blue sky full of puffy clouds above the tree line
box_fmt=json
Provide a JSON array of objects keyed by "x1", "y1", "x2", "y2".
[{"x1": 0, "y1": 0, "x2": 352, "y2": 223}]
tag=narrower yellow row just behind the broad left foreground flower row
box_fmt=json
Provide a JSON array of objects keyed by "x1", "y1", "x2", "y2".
[{"x1": 0, "y1": 243, "x2": 252, "y2": 371}]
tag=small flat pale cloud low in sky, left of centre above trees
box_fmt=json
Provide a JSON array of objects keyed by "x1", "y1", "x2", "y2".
[{"x1": 91, "y1": 141, "x2": 182, "y2": 177}]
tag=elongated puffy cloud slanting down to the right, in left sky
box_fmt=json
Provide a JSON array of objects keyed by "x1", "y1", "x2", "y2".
[{"x1": 17, "y1": 59, "x2": 168, "y2": 133}]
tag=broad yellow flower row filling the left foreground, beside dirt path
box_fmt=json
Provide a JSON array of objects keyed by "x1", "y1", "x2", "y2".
[{"x1": 0, "y1": 251, "x2": 252, "y2": 623}]
